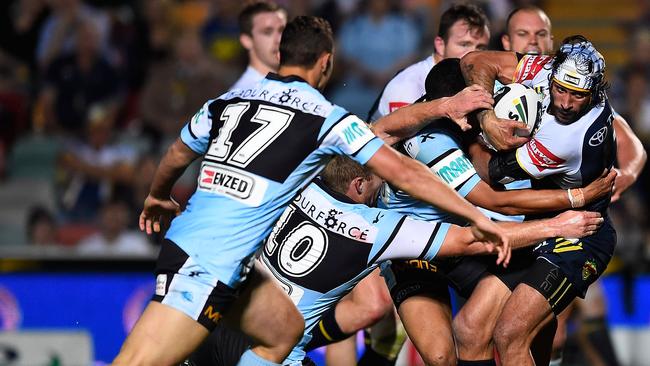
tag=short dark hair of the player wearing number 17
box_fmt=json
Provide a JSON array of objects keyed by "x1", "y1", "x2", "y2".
[{"x1": 280, "y1": 15, "x2": 334, "y2": 67}]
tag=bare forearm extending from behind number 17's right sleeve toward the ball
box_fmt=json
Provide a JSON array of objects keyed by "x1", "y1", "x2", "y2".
[{"x1": 371, "y1": 98, "x2": 447, "y2": 145}]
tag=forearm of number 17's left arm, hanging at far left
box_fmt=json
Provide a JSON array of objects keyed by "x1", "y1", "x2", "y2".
[{"x1": 149, "y1": 138, "x2": 199, "y2": 199}]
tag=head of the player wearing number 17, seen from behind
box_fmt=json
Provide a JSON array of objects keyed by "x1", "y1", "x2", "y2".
[{"x1": 280, "y1": 16, "x2": 334, "y2": 88}]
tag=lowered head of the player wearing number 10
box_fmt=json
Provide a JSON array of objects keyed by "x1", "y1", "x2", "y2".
[{"x1": 321, "y1": 155, "x2": 383, "y2": 206}]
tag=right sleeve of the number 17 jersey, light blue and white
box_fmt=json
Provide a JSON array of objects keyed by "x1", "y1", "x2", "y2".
[{"x1": 321, "y1": 109, "x2": 384, "y2": 164}]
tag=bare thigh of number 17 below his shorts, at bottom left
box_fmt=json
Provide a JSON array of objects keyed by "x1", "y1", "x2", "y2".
[{"x1": 113, "y1": 301, "x2": 208, "y2": 365}]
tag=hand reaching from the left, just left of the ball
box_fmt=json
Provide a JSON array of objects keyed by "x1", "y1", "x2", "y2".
[{"x1": 444, "y1": 84, "x2": 494, "y2": 131}]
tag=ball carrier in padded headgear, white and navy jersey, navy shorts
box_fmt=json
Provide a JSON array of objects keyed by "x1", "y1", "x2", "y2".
[{"x1": 462, "y1": 36, "x2": 616, "y2": 365}]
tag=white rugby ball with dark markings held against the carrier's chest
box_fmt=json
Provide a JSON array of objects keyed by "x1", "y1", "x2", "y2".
[{"x1": 494, "y1": 83, "x2": 542, "y2": 136}]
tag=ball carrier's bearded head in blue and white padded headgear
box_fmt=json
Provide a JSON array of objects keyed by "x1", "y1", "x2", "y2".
[{"x1": 549, "y1": 36, "x2": 607, "y2": 123}]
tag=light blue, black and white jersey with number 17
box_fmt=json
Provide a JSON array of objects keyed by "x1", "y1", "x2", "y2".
[{"x1": 166, "y1": 74, "x2": 383, "y2": 288}]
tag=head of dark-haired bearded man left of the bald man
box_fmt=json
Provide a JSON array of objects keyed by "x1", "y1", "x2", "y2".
[{"x1": 434, "y1": 4, "x2": 490, "y2": 59}]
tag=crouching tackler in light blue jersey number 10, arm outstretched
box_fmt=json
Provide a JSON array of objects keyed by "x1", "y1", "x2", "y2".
[{"x1": 185, "y1": 156, "x2": 601, "y2": 366}]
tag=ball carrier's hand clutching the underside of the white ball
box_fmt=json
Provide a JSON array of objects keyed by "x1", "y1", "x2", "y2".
[{"x1": 479, "y1": 111, "x2": 530, "y2": 151}]
